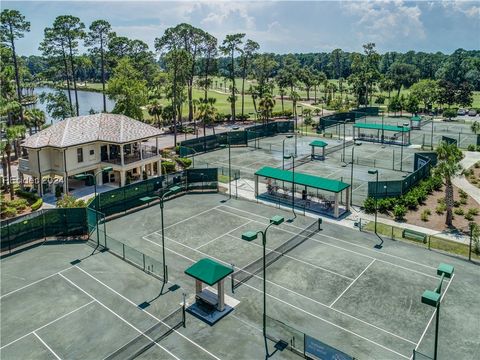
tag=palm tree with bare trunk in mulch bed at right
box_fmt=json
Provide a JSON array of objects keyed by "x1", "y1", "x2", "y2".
[{"x1": 435, "y1": 141, "x2": 463, "y2": 227}]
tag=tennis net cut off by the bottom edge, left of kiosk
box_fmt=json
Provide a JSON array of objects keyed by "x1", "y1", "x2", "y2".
[{"x1": 105, "y1": 306, "x2": 185, "y2": 360}]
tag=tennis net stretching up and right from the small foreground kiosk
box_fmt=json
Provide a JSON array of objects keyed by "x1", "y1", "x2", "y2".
[{"x1": 232, "y1": 221, "x2": 319, "y2": 292}]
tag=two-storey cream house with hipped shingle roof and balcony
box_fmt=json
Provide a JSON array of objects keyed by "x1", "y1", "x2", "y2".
[{"x1": 18, "y1": 113, "x2": 162, "y2": 196}]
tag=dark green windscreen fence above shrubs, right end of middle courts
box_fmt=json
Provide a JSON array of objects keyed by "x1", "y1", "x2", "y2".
[{"x1": 368, "y1": 153, "x2": 436, "y2": 198}]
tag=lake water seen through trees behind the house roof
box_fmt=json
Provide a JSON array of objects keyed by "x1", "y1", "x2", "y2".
[{"x1": 33, "y1": 86, "x2": 115, "y2": 124}]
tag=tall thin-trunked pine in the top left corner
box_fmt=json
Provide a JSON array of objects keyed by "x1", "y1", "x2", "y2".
[{"x1": 0, "y1": 9, "x2": 30, "y2": 121}]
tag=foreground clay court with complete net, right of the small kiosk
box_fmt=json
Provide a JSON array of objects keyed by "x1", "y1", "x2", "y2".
[{"x1": 98, "y1": 194, "x2": 479, "y2": 359}]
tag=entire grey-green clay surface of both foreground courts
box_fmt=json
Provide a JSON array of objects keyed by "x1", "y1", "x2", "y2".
[{"x1": 1, "y1": 194, "x2": 480, "y2": 359}]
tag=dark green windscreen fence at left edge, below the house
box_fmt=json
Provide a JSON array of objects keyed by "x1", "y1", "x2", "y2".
[{"x1": 0, "y1": 208, "x2": 88, "y2": 252}]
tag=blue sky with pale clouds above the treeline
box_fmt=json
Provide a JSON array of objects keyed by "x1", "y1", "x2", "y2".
[{"x1": 1, "y1": 0, "x2": 480, "y2": 55}]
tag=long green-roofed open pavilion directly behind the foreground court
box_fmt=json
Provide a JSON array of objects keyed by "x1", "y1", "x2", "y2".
[{"x1": 255, "y1": 166, "x2": 351, "y2": 218}]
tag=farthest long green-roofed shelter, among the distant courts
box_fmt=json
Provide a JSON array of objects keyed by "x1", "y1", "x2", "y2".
[{"x1": 353, "y1": 123, "x2": 410, "y2": 146}]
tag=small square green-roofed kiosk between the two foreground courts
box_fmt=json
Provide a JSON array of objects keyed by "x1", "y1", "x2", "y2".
[{"x1": 185, "y1": 258, "x2": 233, "y2": 325}]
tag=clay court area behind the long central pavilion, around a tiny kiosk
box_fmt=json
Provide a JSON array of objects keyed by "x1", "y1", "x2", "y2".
[{"x1": 191, "y1": 135, "x2": 420, "y2": 206}]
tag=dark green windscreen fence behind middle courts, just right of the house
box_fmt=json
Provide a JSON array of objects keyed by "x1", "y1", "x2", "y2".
[{"x1": 178, "y1": 120, "x2": 294, "y2": 157}]
